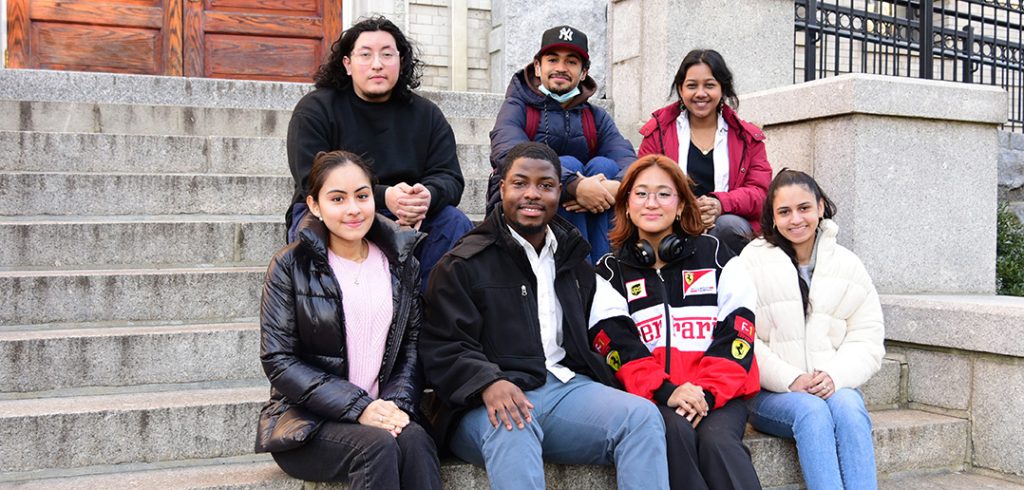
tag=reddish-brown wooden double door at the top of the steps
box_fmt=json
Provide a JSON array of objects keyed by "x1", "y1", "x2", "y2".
[{"x1": 7, "y1": 0, "x2": 341, "y2": 82}]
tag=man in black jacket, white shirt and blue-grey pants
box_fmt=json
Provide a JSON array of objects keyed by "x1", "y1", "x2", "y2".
[{"x1": 420, "y1": 142, "x2": 668, "y2": 489}]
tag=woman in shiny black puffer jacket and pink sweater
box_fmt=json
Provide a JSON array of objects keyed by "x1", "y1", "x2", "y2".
[{"x1": 256, "y1": 151, "x2": 440, "y2": 489}]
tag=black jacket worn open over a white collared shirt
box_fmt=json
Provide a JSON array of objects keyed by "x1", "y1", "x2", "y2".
[{"x1": 420, "y1": 208, "x2": 630, "y2": 443}]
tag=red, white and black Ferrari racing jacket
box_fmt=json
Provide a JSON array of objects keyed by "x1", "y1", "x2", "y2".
[{"x1": 590, "y1": 235, "x2": 760, "y2": 409}]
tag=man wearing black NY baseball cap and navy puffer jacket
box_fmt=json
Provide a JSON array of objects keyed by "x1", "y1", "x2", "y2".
[{"x1": 487, "y1": 26, "x2": 636, "y2": 263}]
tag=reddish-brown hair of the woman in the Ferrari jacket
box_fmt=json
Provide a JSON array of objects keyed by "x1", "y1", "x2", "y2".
[{"x1": 608, "y1": 154, "x2": 703, "y2": 250}]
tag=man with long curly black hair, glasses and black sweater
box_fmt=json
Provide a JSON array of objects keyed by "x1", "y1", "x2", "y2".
[{"x1": 286, "y1": 17, "x2": 472, "y2": 284}]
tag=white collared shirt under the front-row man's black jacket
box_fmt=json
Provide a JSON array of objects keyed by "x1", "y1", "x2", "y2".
[{"x1": 509, "y1": 226, "x2": 575, "y2": 383}]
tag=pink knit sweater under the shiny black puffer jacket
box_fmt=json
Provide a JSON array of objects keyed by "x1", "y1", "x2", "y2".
[{"x1": 328, "y1": 241, "x2": 394, "y2": 398}]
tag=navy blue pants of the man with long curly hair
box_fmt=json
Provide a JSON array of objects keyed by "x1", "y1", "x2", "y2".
[{"x1": 288, "y1": 203, "x2": 473, "y2": 293}]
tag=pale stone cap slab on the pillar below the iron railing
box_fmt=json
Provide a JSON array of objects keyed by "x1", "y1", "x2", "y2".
[{"x1": 740, "y1": 74, "x2": 1007, "y2": 126}]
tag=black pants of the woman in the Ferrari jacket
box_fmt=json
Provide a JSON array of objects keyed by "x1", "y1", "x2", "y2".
[{"x1": 657, "y1": 400, "x2": 761, "y2": 490}]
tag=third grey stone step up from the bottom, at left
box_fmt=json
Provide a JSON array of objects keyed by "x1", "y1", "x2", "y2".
[{"x1": 0, "y1": 322, "x2": 263, "y2": 399}]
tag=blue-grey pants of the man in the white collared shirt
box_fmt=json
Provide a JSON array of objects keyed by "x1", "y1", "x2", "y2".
[{"x1": 451, "y1": 372, "x2": 669, "y2": 490}]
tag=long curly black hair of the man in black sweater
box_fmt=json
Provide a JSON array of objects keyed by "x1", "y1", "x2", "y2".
[{"x1": 313, "y1": 15, "x2": 423, "y2": 99}]
